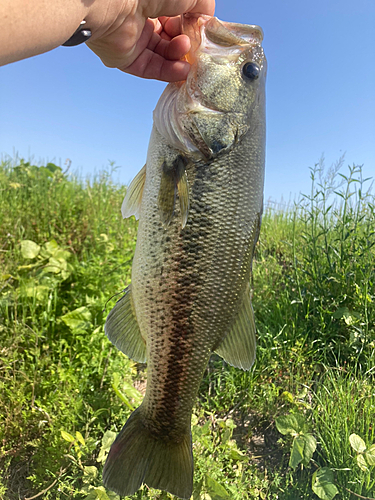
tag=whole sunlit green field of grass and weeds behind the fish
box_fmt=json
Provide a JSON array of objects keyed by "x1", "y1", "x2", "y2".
[{"x1": 0, "y1": 160, "x2": 375, "y2": 500}]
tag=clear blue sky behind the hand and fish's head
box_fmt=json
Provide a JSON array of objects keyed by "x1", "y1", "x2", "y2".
[{"x1": 0, "y1": 0, "x2": 375, "y2": 201}]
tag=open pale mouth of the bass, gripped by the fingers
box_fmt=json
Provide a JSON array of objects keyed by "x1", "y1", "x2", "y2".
[{"x1": 181, "y1": 13, "x2": 263, "y2": 64}]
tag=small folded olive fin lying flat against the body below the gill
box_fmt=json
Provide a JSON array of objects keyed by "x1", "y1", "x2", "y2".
[{"x1": 158, "y1": 155, "x2": 189, "y2": 228}]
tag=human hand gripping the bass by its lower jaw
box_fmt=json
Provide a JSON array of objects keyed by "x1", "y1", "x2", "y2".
[{"x1": 86, "y1": 0, "x2": 215, "y2": 82}]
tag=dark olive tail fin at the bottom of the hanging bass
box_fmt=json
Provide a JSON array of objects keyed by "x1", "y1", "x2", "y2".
[{"x1": 103, "y1": 408, "x2": 193, "y2": 498}]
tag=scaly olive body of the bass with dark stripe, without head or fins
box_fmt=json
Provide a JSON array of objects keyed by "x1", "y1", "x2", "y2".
[{"x1": 132, "y1": 122, "x2": 264, "y2": 433}]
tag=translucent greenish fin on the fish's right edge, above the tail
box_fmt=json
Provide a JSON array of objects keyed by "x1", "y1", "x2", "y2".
[{"x1": 215, "y1": 289, "x2": 256, "y2": 370}]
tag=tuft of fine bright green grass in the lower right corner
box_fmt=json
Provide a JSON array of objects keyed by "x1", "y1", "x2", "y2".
[{"x1": 313, "y1": 369, "x2": 375, "y2": 496}]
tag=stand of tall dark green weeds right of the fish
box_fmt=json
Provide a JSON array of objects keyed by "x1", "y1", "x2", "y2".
[{"x1": 254, "y1": 160, "x2": 375, "y2": 371}]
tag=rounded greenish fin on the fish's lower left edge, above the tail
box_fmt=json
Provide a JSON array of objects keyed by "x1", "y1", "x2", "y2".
[{"x1": 105, "y1": 285, "x2": 146, "y2": 363}]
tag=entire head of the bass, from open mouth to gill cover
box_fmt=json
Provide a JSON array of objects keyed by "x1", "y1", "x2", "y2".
[{"x1": 154, "y1": 14, "x2": 267, "y2": 159}]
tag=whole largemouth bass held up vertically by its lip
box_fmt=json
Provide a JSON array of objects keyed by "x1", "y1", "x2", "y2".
[{"x1": 103, "y1": 15, "x2": 267, "y2": 499}]
